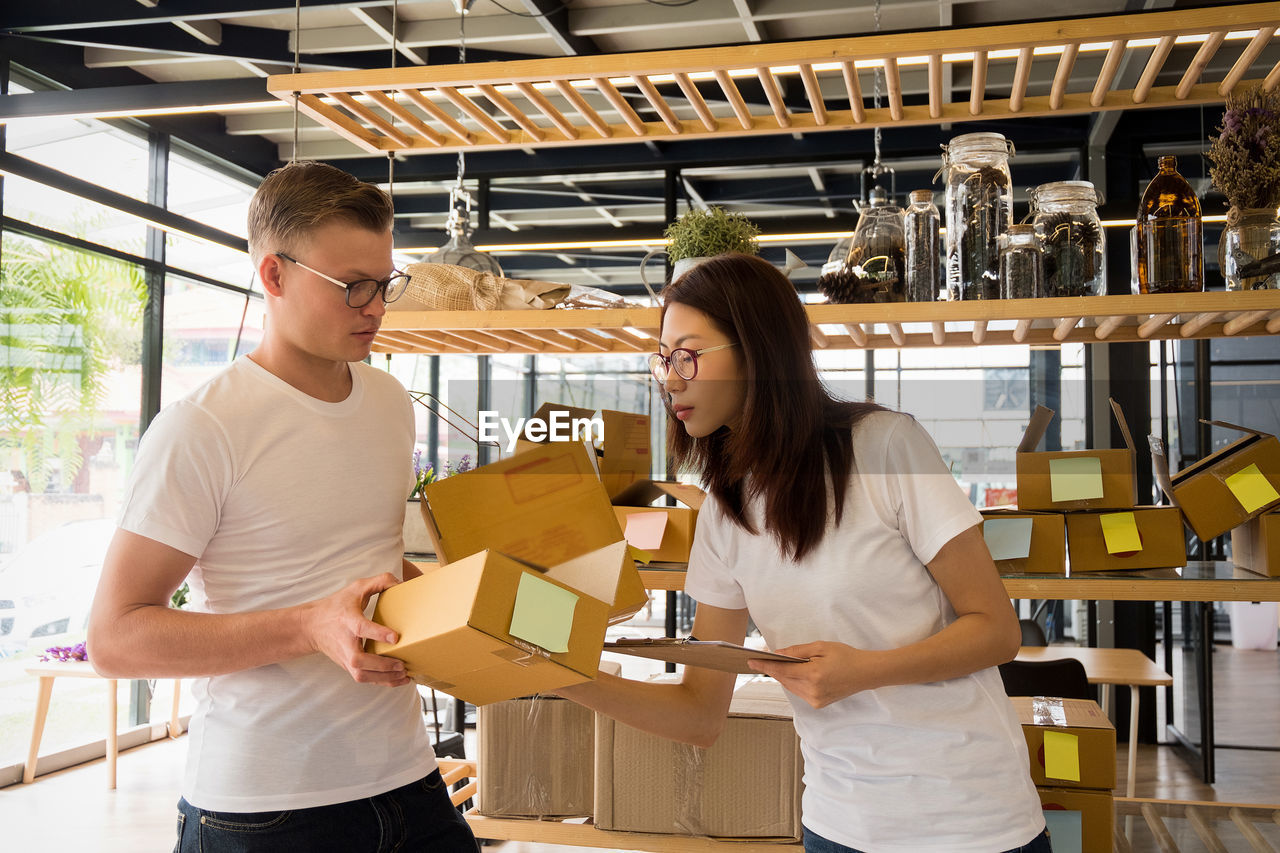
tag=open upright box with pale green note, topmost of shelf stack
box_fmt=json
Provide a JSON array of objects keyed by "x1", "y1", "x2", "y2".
[{"x1": 1014, "y1": 400, "x2": 1138, "y2": 511}]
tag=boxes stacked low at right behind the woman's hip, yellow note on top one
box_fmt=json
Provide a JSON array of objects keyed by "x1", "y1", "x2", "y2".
[{"x1": 1011, "y1": 697, "x2": 1116, "y2": 853}]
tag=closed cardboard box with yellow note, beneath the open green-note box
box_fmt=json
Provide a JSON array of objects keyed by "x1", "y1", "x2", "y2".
[{"x1": 1066, "y1": 506, "x2": 1187, "y2": 575}]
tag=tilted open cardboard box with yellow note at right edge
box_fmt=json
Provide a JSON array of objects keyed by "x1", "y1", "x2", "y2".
[{"x1": 1148, "y1": 420, "x2": 1280, "y2": 542}]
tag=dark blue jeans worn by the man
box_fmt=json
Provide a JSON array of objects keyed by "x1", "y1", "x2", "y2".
[{"x1": 173, "y1": 770, "x2": 479, "y2": 853}]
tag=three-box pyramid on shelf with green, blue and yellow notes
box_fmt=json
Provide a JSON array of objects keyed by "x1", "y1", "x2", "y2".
[{"x1": 983, "y1": 401, "x2": 1187, "y2": 573}]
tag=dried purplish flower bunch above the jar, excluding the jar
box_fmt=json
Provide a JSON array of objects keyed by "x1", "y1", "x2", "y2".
[{"x1": 1208, "y1": 86, "x2": 1280, "y2": 210}]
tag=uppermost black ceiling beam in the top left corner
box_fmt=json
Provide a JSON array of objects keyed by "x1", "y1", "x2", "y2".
[{"x1": 0, "y1": 0, "x2": 387, "y2": 32}]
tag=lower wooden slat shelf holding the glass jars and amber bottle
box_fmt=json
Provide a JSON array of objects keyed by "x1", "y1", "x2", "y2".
[{"x1": 374, "y1": 291, "x2": 1280, "y2": 355}]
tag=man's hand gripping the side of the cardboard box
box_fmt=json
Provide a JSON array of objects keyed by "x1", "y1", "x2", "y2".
[{"x1": 302, "y1": 571, "x2": 410, "y2": 686}]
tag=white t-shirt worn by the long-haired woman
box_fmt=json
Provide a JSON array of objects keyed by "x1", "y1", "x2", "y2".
[{"x1": 685, "y1": 412, "x2": 1044, "y2": 853}]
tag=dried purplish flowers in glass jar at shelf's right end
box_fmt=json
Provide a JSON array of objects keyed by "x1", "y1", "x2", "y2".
[{"x1": 1208, "y1": 87, "x2": 1280, "y2": 291}]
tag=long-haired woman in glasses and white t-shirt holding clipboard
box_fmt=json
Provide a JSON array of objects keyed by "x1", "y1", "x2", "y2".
[{"x1": 561, "y1": 255, "x2": 1050, "y2": 853}]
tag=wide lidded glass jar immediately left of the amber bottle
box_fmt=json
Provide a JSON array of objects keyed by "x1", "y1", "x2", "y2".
[{"x1": 1032, "y1": 181, "x2": 1107, "y2": 296}]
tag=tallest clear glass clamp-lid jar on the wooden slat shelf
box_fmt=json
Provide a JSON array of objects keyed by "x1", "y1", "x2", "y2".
[{"x1": 942, "y1": 133, "x2": 1014, "y2": 300}]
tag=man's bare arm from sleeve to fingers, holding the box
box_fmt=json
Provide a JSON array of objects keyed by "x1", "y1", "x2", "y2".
[{"x1": 88, "y1": 530, "x2": 410, "y2": 686}]
